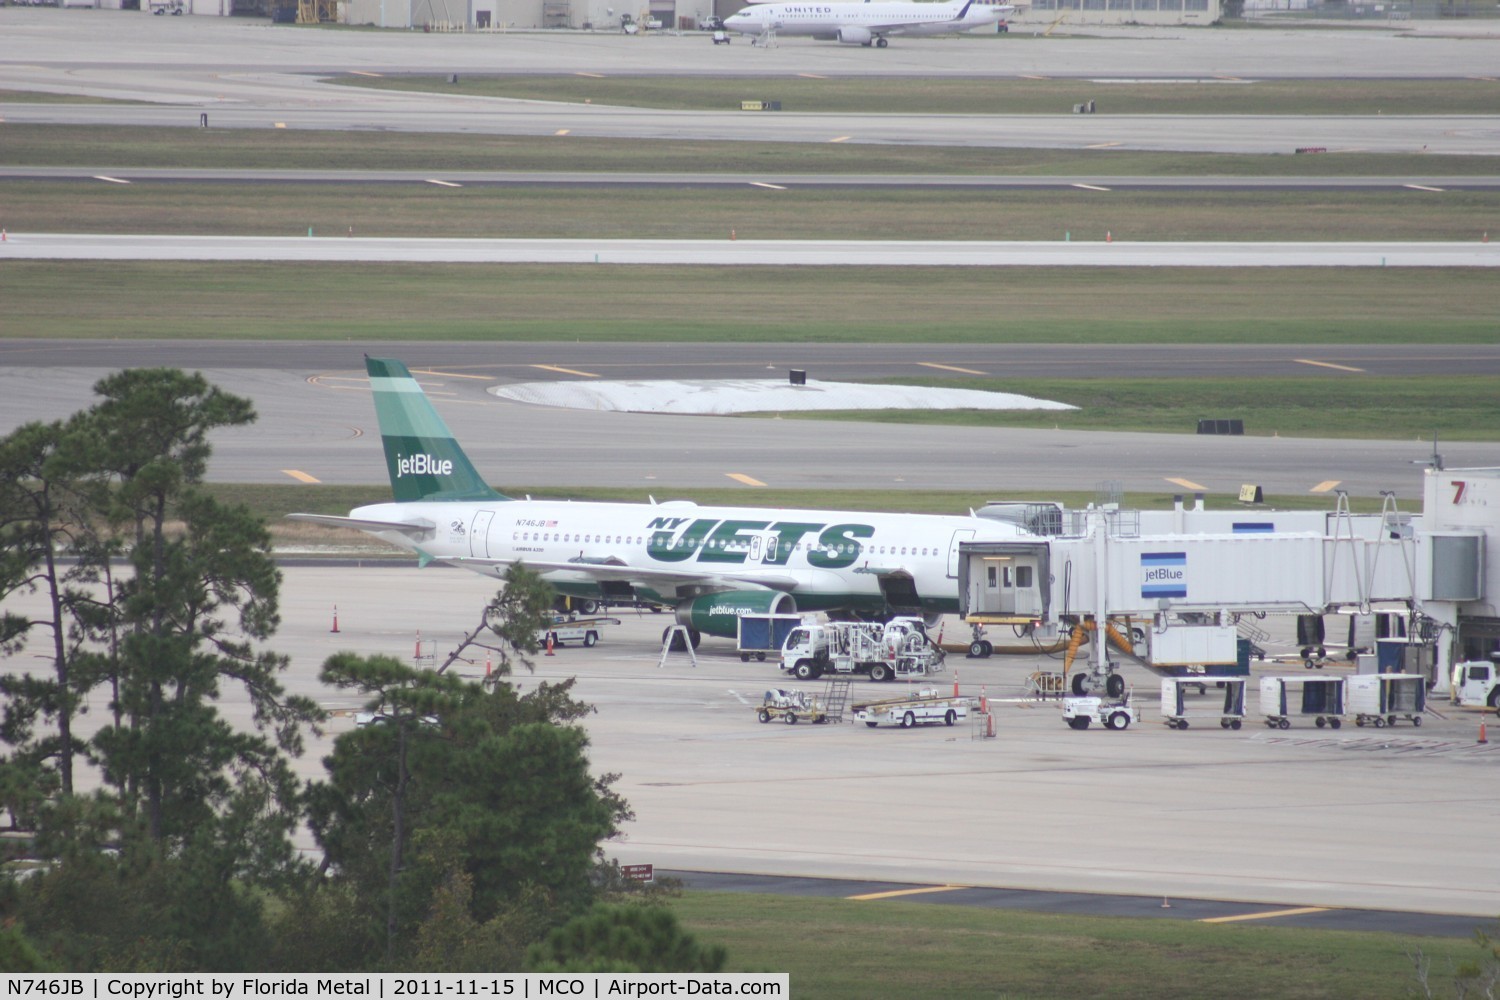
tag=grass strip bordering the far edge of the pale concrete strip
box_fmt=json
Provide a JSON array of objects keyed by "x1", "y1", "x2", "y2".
[{"x1": 5, "y1": 181, "x2": 1500, "y2": 243}]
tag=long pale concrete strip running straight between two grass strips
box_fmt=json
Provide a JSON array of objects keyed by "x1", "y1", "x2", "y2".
[{"x1": 0, "y1": 232, "x2": 1500, "y2": 268}]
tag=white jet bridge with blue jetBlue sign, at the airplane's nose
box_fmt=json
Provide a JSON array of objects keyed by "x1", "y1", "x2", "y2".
[{"x1": 959, "y1": 485, "x2": 1500, "y2": 693}]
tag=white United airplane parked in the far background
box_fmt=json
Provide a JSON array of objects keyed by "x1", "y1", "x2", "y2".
[{"x1": 725, "y1": 0, "x2": 1016, "y2": 48}]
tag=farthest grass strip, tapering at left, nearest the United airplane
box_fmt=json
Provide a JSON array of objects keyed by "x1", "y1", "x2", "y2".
[{"x1": 335, "y1": 73, "x2": 1500, "y2": 115}]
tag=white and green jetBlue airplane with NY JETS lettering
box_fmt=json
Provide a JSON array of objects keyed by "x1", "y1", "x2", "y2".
[{"x1": 290, "y1": 357, "x2": 1022, "y2": 645}]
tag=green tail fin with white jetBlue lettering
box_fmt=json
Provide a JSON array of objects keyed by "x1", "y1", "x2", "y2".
[{"x1": 365, "y1": 355, "x2": 509, "y2": 502}]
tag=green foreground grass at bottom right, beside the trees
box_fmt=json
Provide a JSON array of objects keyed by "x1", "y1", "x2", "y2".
[{"x1": 672, "y1": 892, "x2": 1493, "y2": 1000}]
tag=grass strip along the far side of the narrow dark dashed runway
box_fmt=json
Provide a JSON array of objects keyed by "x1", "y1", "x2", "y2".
[{"x1": 0, "y1": 125, "x2": 1500, "y2": 179}]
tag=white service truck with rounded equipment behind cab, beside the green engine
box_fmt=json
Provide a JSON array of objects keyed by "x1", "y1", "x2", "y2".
[{"x1": 782, "y1": 618, "x2": 944, "y2": 681}]
